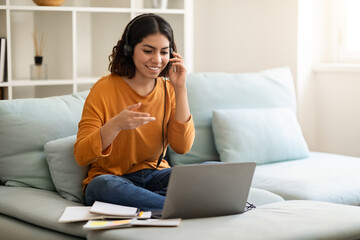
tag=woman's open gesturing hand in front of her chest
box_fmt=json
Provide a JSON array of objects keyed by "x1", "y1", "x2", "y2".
[{"x1": 114, "y1": 102, "x2": 155, "y2": 131}]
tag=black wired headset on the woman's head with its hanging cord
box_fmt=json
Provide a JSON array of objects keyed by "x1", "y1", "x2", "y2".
[{"x1": 123, "y1": 13, "x2": 174, "y2": 171}]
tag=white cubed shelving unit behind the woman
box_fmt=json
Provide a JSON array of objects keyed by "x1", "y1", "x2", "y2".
[{"x1": 0, "y1": 0, "x2": 193, "y2": 99}]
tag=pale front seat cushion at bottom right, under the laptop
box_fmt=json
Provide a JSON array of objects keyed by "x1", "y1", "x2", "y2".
[{"x1": 88, "y1": 200, "x2": 360, "y2": 240}]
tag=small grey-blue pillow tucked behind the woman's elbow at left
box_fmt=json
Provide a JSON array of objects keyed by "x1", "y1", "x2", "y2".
[{"x1": 44, "y1": 135, "x2": 88, "y2": 202}]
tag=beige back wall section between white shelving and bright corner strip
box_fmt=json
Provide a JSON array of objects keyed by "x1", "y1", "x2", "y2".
[{"x1": 194, "y1": 0, "x2": 297, "y2": 74}]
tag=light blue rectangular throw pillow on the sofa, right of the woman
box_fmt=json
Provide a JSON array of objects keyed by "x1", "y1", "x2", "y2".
[{"x1": 212, "y1": 108, "x2": 309, "y2": 164}]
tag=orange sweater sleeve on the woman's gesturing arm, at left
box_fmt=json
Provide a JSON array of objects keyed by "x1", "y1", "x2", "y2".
[{"x1": 74, "y1": 86, "x2": 112, "y2": 166}]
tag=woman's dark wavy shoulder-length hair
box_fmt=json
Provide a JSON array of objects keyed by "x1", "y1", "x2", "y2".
[{"x1": 108, "y1": 13, "x2": 177, "y2": 78}]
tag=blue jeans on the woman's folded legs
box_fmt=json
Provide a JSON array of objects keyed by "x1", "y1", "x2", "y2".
[{"x1": 84, "y1": 168, "x2": 171, "y2": 211}]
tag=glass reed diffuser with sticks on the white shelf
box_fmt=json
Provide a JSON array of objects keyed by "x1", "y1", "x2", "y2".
[{"x1": 30, "y1": 32, "x2": 47, "y2": 80}]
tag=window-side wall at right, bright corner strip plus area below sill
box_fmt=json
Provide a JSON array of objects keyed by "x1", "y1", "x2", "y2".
[{"x1": 297, "y1": 0, "x2": 360, "y2": 156}]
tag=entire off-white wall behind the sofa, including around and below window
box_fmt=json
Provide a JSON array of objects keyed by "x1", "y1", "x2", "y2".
[{"x1": 194, "y1": 0, "x2": 360, "y2": 156}]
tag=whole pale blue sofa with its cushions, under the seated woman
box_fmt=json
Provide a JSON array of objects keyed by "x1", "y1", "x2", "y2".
[{"x1": 0, "y1": 67, "x2": 360, "y2": 240}]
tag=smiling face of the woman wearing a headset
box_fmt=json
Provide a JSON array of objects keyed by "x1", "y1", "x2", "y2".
[{"x1": 133, "y1": 33, "x2": 170, "y2": 79}]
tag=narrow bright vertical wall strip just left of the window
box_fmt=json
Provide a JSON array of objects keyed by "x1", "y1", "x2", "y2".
[{"x1": 296, "y1": 0, "x2": 329, "y2": 151}]
